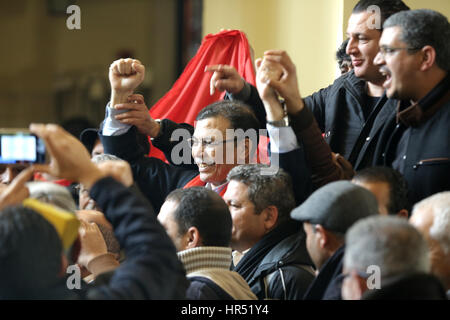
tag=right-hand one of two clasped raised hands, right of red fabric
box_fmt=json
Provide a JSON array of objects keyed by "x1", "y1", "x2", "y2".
[{"x1": 264, "y1": 50, "x2": 304, "y2": 114}]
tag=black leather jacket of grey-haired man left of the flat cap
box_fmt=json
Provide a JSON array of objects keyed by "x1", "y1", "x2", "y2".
[{"x1": 234, "y1": 221, "x2": 314, "y2": 300}]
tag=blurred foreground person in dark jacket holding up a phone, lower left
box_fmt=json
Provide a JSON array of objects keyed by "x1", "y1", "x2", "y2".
[{"x1": 0, "y1": 125, "x2": 188, "y2": 299}]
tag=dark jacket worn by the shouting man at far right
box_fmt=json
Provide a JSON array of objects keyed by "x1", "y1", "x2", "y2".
[{"x1": 374, "y1": 75, "x2": 450, "y2": 205}]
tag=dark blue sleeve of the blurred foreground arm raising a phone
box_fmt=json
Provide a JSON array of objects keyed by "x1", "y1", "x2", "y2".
[{"x1": 61, "y1": 178, "x2": 189, "y2": 299}]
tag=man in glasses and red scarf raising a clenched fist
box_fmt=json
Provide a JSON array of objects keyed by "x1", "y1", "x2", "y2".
[{"x1": 100, "y1": 59, "x2": 259, "y2": 212}]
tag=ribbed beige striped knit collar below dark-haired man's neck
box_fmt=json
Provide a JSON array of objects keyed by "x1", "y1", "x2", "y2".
[{"x1": 178, "y1": 247, "x2": 231, "y2": 275}]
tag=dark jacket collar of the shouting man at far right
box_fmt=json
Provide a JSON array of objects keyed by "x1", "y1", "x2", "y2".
[{"x1": 397, "y1": 74, "x2": 450, "y2": 127}]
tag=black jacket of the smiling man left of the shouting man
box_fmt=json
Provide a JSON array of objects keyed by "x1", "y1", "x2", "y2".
[{"x1": 244, "y1": 71, "x2": 396, "y2": 170}]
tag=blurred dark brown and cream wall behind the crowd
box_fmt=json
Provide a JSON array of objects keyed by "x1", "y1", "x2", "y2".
[{"x1": 0, "y1": 0, "x2": 450, "y2": 135}]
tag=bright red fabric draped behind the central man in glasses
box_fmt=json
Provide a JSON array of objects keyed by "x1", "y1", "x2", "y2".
[{"x1": 150, "y1": 30, "x2": 256, "y2": 159}]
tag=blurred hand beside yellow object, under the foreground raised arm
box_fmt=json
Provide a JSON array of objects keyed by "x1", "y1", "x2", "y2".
[{"x1": 77, "y1": 220, "x2": 108, "y2": 268}]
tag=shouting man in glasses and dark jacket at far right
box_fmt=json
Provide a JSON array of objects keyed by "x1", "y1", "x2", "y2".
[{"x1": 375, "y1": 10, "x2": 450, "y2": 205}]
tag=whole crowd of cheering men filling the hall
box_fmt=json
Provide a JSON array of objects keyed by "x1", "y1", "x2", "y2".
[{"x1": 0, "y1": 0, "x2": 450, "y2": 300}]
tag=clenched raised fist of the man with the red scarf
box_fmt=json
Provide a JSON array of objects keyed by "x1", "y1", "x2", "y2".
[{"x1": 109, "y1": 59, "x2": 145, "y2": 108}]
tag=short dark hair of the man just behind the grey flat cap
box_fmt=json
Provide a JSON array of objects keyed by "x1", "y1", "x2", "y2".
[{"x1": 353, "y1": 167, "x2": 410, "y2": 215}]
